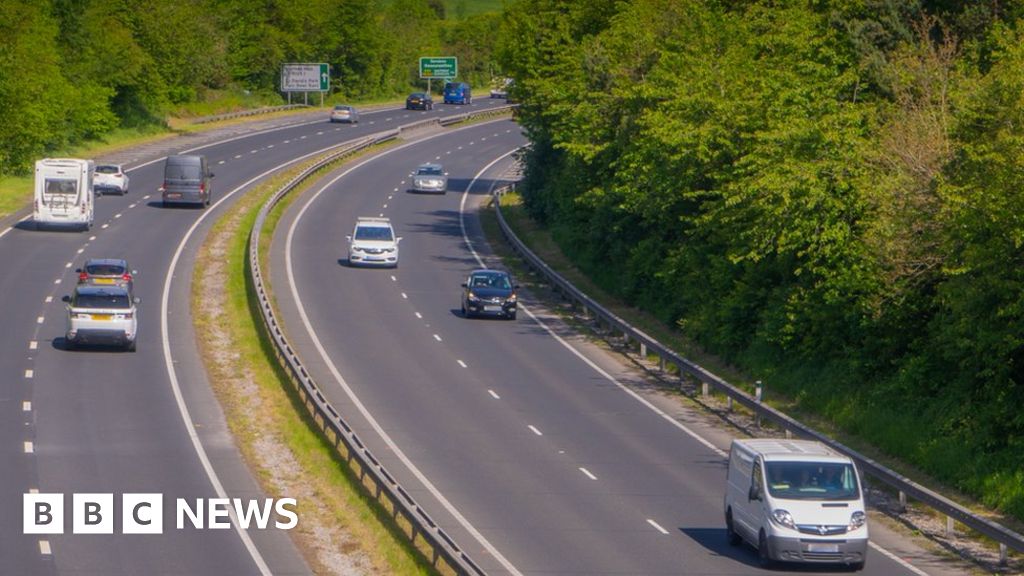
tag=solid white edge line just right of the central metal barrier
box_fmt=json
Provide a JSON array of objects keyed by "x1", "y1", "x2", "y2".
[{"x1": 286, "y1": 120, "x2": 523, "y2": 576}]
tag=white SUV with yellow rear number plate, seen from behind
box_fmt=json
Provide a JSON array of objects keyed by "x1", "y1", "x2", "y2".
[{"x1": 61, "y1": 284, "x2": 139, "y2": 352}]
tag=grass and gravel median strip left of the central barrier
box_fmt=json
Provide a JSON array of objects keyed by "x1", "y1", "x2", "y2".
[{"x1": 191, "y1": 143, "x2": 434, "y2": 575}]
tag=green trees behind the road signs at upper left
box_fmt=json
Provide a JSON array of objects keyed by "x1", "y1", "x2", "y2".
[{"x1": 0, "y1": 0, "x2": 499, "y2": 175}]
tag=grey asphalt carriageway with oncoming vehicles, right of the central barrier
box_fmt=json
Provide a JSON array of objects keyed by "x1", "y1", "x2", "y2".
[{"x1": 270, "y1": 121, "x2": 958, "y2": 575}]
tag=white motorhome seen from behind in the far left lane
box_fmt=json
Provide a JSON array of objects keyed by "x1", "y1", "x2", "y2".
[{"x1": 32, "y1": 158, "x2": 95, "y2": 230}]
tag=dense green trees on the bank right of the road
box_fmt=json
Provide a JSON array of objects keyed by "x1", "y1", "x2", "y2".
[{"x1": 497, "y1": 0, "x2": 1024, "y2": 519}]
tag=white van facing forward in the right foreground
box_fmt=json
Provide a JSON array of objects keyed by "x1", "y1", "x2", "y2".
[{"x1": 725, "y1": 439, "x2": 867, "y2": 570}]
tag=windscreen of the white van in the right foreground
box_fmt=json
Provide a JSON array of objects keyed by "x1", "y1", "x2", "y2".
[{"x1": 765, "y1": 462, "x2": 860, "y2": 500}]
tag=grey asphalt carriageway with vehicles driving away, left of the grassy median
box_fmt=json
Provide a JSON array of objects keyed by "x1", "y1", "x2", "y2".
[{"x1": 0, "y1": 101, "x2": 507, "y2": 575}]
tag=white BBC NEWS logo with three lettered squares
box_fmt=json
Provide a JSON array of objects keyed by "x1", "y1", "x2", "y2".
[{"x1": 22, "y1": 493, "x2": 299, "y2": 534}]
